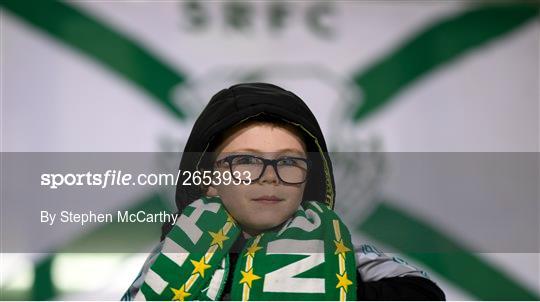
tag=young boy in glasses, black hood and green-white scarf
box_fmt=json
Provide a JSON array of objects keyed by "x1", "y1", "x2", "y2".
[{"x1": 122, "y1": 83, "x2": 444, "y2": 301}]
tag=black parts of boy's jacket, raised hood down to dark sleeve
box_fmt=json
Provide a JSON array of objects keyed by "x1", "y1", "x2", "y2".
[{"x1": 162, "y1": 83, "x2": 444, "y2": 300}]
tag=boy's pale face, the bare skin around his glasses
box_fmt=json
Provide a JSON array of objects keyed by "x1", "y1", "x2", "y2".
[{"x1": 207, "y1": 123, "x2": 306, "y2": 236}]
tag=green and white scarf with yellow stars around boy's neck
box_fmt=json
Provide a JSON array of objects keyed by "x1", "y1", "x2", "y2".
[{"x1": 135, "y1": 197, "x2": 356, "y2": 301}]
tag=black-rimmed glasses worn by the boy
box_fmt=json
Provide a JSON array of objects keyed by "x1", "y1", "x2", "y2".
[{"x1": 216, "y1": 154, "x2": 310, "y2": 185}]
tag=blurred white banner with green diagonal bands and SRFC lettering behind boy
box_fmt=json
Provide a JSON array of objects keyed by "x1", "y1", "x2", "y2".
[{"x1": 0, "y1": 0, "x2": 540, "y2": 300}]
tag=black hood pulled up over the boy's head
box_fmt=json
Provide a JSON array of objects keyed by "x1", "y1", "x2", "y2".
[{"x1": 176, "y1": 83, "x2": 335, "y2": 212}]
